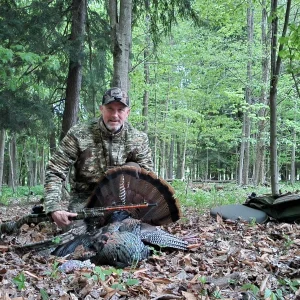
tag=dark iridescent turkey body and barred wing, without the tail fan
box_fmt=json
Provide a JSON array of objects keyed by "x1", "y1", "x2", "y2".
[{"x1": 52, "y1": 211, "x2": 187, "y2": 267}]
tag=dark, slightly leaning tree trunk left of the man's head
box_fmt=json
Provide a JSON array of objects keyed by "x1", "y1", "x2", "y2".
[{"x1": 60, "y1": 0, "x2": 87, "y2": 139}]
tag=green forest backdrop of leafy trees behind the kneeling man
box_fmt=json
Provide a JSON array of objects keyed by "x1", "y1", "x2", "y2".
[{"x1": 0, "y1": 0, "x2": 300, "y2": 191}]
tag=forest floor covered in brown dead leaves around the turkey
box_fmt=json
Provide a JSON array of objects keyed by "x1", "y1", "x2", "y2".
[{"x1": 0, "y1": 195, "x2": 300, "y2": 300}]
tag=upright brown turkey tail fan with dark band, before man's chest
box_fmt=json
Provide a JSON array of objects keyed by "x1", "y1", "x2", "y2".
[{"x1": 86, "y1": 166, "x2": 181, "y2": 226}]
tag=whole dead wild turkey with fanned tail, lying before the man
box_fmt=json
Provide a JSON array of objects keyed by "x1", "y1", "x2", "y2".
[{"x1": 17, "y1": 166, "x2": 187, "y2": 267}]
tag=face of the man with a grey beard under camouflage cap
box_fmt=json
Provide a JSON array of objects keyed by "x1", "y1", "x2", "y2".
[{"x1": 100, "y1": 101, "x2": 130, "y2": 133}]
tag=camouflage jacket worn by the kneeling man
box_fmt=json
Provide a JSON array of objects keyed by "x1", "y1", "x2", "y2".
[{"x1": 44, "y1": 118, "x2": 153, "y2": 213}]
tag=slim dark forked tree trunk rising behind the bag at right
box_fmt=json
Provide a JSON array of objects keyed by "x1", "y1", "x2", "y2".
[{"x1": 270, "y1": 0, "x2": 291, "y2": 196}]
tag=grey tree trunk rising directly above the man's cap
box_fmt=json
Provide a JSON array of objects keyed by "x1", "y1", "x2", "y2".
[{"x1": 108, "y1": 0, "x2": 132, "y2": 91}]
